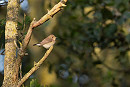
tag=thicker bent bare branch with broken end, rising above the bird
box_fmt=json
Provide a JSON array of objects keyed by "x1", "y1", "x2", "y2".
[{"x1": 17, "y1": 0, "x2": 67, "y2": 59}]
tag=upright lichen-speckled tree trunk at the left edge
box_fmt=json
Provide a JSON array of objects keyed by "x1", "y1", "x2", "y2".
[{"x1": 2, "y1": 0, "x2": 19, "y2": 87}]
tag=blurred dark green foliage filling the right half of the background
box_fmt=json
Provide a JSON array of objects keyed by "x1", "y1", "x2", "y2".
[{"x1": 55, "y1": 0, "x2": 130, "y2": 87}]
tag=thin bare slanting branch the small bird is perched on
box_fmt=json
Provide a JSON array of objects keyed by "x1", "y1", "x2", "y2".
[{"x1": 17, "y1": 46, "x2": 53, "y2": 87}]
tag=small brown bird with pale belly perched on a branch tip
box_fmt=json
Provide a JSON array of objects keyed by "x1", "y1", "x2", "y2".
[{"x1": 33, "y1": 34, "x2": 56, "y2": 49}]
